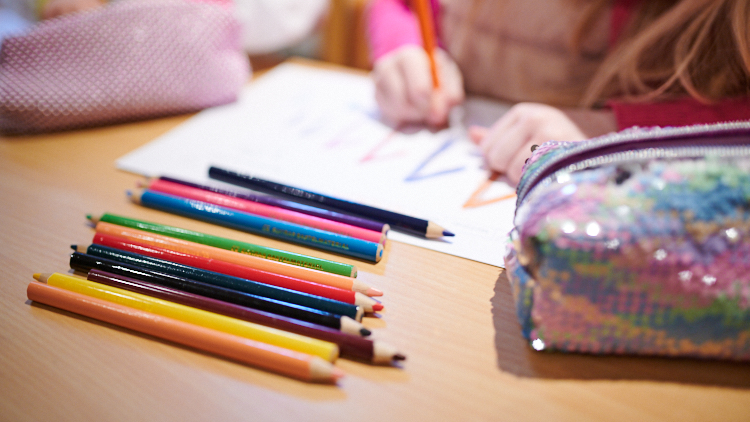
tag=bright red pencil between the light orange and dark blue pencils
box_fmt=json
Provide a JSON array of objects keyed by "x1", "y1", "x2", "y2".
[{"x1": 94, "y1": 233, "x2": 383, "y2": 312}]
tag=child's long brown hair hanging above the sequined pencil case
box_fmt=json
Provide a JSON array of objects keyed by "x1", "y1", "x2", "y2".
[{"x1": 582, "y1": 0, "x2": 750, "y2": 107}]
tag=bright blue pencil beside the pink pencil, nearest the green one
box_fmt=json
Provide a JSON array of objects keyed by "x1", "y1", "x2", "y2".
[{"x1": 128, "y1": 189, "x2": 383, "y2": 262}]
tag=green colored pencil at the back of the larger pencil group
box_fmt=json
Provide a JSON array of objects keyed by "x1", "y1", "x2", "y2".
[{"x1": 86, "y1": 213, "x2": 357, "y2": 277}]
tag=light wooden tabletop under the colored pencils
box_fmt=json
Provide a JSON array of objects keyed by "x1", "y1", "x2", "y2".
[{"x1": 0, "y1": 61, "x2": 750, "y2": 422}]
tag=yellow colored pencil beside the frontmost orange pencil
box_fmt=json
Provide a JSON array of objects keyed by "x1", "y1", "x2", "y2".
[{"x1": 34, "y1": 273, "x2": 339, "y2": 362}]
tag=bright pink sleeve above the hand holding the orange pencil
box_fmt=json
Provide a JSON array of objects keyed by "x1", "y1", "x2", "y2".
[{"x1": 367, "y1": 0, "x2": 422, "y2": 61}]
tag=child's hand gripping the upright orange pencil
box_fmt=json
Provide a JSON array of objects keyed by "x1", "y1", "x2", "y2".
[{"x1": 372, "y1": 45, "x2": 464, "y2": 126}]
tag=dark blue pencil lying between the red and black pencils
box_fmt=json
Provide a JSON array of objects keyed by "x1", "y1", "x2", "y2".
[{"x1": 76, "y1": 244, "x2": 364, "y2": 321}]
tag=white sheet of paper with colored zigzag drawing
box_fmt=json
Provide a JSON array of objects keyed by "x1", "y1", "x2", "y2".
[{"x1": 117, "y1": 64, "x2": 515, "y2": 266}]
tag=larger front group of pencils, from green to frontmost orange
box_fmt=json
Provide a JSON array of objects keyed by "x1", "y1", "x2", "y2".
[{"x1": 27, "y1": 211, "x2": 405, "y2": 382}]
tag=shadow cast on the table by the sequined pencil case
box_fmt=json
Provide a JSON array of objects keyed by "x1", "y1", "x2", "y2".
[{"x1": 492, "y1": 272, "x2": 750, "y2": 388}]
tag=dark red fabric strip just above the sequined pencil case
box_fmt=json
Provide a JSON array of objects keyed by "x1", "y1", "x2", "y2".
[{"x1": 608, "y1": 97, "x2": 750, "y2": 130}]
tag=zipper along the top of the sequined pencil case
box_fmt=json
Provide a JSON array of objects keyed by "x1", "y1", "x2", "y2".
[{"x1": 516, "y1": 122, "x2": 750, "y2": 205}]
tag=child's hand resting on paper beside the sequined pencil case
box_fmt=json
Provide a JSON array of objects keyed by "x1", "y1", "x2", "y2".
[{"x1": 469, "y1": 103, "x2": 587, "y2": 183}]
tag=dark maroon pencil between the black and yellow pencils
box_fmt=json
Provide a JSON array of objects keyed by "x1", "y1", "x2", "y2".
[{"x1": 87, "y1": 269, "x2": 405, "y2": 363}]
